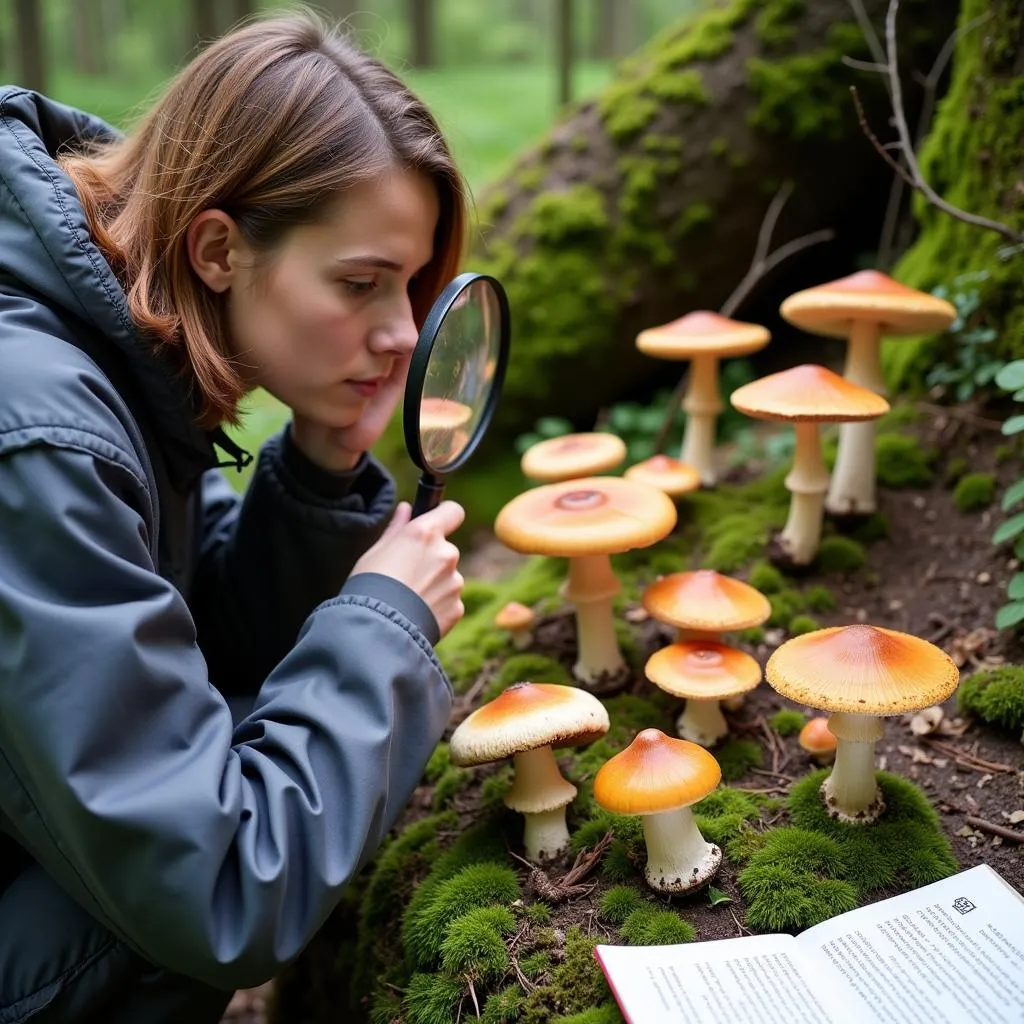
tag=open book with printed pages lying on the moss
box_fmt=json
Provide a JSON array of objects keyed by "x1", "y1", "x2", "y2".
[{"x1": 594, "y1": 864, "x2": 1024, "y2": 1024}]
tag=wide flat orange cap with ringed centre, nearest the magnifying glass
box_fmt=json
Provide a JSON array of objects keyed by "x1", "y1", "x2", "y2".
[{"x1": 495, "y1": 476, "x2": 676, "y2": 558}]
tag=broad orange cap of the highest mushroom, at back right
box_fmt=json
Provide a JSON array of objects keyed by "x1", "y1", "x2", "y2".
[{"x1": 780, "y1": 270, "x2": 956, "y2": 338}]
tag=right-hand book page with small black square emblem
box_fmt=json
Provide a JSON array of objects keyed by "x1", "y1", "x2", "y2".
[{"x1": 796, "y1": 864, "x2": 1024, "y2": 1024}]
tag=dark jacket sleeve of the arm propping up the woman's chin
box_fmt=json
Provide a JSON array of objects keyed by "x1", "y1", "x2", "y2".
[{"x1": 189, "y1": 428, "x2": 438, "y2": 693}]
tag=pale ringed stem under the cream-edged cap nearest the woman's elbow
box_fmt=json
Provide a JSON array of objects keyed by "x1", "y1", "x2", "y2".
[{"x1": 505, "y1": 746, "x2": 577, "y2": 863}]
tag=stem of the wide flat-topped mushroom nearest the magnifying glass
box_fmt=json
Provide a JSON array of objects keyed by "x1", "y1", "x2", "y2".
[{"x1": 562, "y1": 555, "x2": 626, "y2": 683}]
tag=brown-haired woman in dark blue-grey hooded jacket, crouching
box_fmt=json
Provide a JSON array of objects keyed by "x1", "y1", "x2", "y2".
[{"x1": 0, "y1": 9, "x2": 464, "y2": 1024}]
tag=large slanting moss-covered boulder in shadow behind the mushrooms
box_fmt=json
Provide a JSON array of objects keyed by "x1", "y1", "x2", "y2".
[{"x1": 472, "y1": 0, "x2": 957, "y2": 436}]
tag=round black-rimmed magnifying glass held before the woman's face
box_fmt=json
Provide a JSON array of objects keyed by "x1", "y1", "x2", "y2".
[{"x1": 402, "y1": 273, "x2": 511, "y2": 516}]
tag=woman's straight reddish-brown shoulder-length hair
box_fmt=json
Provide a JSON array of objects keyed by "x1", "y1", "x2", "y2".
[{"x1": 61, "y1": 12, "x2": 466, "y2": 426}]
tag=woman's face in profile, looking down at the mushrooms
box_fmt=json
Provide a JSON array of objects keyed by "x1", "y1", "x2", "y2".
[{"x1": 227, "y1": 169, "x2": 438, "y2": 427}]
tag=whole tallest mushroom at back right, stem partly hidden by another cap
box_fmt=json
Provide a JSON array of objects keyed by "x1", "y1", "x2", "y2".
[{"x1": 780, "y1": 270, "x2": 956, "y2": 515}]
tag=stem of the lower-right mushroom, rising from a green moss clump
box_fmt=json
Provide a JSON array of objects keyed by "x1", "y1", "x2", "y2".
[{"x1": 821, "y1": 712, "x2": 885, "y2": 824}]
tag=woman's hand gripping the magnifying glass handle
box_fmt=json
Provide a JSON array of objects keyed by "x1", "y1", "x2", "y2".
[{"x1": 352, "y1": 502, "x2": 466, "y2": 637}]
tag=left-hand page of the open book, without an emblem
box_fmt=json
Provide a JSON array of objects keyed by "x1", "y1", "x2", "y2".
[{"x1": 594, "y1": 935, "x2": 849, "y2": 1024}]
